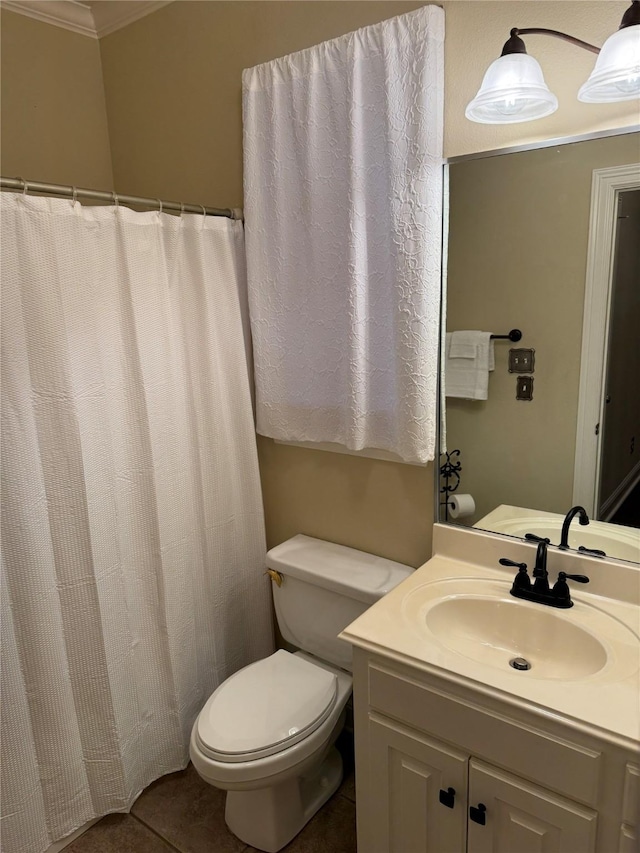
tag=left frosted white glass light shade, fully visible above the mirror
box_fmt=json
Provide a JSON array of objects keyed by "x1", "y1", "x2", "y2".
[{"x1": 464, "y1": 53, "x2": 558, "y2": 124}]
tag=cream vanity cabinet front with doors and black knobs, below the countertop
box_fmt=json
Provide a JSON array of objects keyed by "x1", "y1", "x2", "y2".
[{"x1": 354, "y1": 648, "x2": 640, "y2": 853}]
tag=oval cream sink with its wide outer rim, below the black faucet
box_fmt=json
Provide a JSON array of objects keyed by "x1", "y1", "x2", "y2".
[{"x1": 402, "y1": 578, "x2": 639, "y2": 681}]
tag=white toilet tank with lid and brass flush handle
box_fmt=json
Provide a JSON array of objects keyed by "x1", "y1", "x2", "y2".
[{"x1": 267, "y1": 534, "x2": 413, "y2": 671}]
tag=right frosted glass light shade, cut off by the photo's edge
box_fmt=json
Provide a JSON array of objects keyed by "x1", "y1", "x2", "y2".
[{"x1": 578, "y1": 24, "x2": 640, "y2": 104}]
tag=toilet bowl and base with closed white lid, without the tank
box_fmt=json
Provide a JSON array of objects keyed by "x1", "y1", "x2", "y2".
[{"x1": 190, "y1": 650, "x2": 351, "y2": 853}]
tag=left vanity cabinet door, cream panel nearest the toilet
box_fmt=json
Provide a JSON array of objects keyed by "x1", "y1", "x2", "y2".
[{"x1": 368, "y1": 714, "x2": 469, "y2": 853}]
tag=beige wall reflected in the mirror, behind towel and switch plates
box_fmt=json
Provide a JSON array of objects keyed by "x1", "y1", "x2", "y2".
[{"x1": 447, "y1": 133, "x2": 640, "y2": 523}]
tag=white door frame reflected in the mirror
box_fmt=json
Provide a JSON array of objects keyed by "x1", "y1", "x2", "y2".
[{"x1": 573, "y1": 163, "x2": 640, "y2": 517}]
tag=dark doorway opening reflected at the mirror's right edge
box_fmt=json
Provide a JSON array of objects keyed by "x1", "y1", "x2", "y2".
[{"x1": 597, "y1": 190, "x2": 640, "y2": 524}]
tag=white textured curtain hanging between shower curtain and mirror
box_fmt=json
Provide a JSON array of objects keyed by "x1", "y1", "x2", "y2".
[{"x1": 243, "y1": 6, "x2": 444, "y2": 462}]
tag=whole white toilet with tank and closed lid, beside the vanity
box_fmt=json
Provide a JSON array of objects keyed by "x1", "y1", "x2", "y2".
[{"x1": 190, "y1": 535, "x2": 413, "y2": 853}]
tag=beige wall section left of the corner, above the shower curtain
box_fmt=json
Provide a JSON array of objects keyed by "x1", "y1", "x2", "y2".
[{"x1": 0, "y1": 9, "x2": 112, "y2": 189}]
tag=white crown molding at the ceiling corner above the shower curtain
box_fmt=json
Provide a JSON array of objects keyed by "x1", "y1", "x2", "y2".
[{"x1": 0, "y1": 0, "x2": 172, "y2": 39}]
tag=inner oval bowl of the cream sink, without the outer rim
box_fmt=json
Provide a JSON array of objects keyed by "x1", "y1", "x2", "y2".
[{"x1": 426, "y1": 597, "x2": 607, "y2": 679}]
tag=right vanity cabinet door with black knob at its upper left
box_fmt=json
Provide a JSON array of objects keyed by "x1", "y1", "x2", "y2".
[{"x1": 468, "y1": 759, "x2": 597, "y2": 853}]
